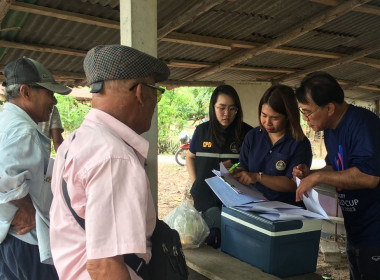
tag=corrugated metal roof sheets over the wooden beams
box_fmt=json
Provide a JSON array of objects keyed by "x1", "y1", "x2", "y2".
[{"x1": 0, "y1": 0, "x2": 380, "y2": 99}]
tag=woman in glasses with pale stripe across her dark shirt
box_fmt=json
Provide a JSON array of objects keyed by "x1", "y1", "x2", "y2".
[{"x1": 186, "y1": 85, "x2": 252, "y2": 248}]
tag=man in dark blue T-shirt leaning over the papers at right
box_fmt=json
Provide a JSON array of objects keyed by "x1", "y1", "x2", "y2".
[{"x1": 293, "y1": 72, "x2": 380, "y2": 280}]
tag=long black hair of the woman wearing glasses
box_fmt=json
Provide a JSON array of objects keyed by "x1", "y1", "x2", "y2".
[{"x1": 209, "y1": 85, "x2": 243, "y2": 148}]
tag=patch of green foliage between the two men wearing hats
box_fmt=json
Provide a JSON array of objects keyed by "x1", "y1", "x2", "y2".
[{"x1": 55, "y1": 94, "x2": 91, "y2": 134}]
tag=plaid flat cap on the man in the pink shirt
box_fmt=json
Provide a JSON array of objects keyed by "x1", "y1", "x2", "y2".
[{"x1": 83, "y1": 45, "x2": 170, "y2": 93}]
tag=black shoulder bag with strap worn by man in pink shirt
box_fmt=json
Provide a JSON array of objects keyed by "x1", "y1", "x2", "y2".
[{"x1": 62, "y1": 179, "x2": 188, "y2": 280}]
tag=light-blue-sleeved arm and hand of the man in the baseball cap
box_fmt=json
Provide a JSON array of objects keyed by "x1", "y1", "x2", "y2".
[{"x1": 0, "y1": 133, "x2": 43, "y2": 235}]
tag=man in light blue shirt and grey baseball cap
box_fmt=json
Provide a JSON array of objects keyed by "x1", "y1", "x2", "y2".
[{"x1": 0, "y1": 57, "x2": 71, "y2": 280}]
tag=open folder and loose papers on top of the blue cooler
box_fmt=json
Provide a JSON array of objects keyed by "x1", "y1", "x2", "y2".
[{"x1": 205, "y1": 163, "x2": 329, "y2": 221}]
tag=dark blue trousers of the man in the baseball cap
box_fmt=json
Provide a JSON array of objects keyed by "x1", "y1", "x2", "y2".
[{"x1": 0, "y1": 234, "x2": 58, "y2": 280}]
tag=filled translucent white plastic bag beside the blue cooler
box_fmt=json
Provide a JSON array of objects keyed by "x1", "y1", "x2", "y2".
[{"x1": 164, "y1": 199, "x2": 210, "y2": 249}]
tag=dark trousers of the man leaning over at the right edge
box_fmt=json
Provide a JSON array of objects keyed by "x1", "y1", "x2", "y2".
[{"x1": 347, "y1": 243, "x2": 380, "y2": 280}]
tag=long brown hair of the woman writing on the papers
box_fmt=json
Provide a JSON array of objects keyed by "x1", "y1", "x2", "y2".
[{"x1": 259, "y1": 85, "x2": 305, "y2": 141}]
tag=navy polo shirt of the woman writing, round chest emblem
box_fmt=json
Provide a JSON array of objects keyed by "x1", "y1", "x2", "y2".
[{"x1": 240, "y1": 127, "x2": 313, "y2": 204}]
